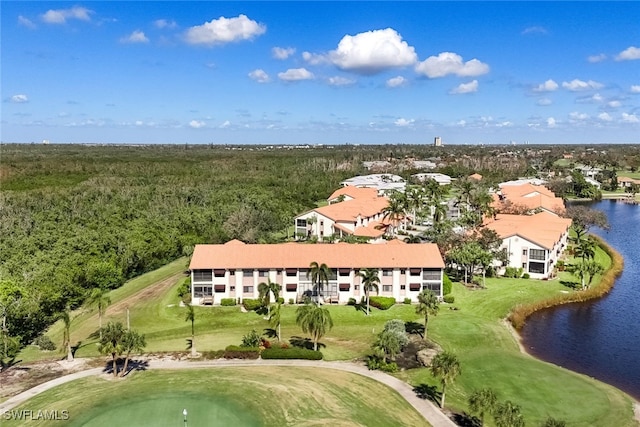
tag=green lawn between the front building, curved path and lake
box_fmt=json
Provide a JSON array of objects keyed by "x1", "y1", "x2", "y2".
[{"x1": 17, "y1": 250, "x2": 635, "y2": 426}]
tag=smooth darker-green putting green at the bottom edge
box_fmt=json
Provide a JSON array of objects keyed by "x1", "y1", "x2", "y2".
[{"x1": 68, "y1": 392, "x2": 262, "y2": 427}]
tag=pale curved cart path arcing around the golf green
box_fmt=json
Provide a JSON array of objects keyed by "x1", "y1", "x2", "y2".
[{"x1": 0, "y1": 359, "x2": 456, "y2": 427}]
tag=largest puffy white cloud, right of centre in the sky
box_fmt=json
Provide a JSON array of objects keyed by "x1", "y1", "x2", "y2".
[{"x1": 328, "y1": 28, "x2": 418, "y2": 74}]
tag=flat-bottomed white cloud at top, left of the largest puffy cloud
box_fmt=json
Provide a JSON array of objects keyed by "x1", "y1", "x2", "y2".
[{"x1": 185, "y1": 15, "x2": 267, "y2": 46}]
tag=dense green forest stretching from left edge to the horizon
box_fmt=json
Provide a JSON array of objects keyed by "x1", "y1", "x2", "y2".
[{"x1": 0, "y1": 144, "x2": 638, "y2": 351}]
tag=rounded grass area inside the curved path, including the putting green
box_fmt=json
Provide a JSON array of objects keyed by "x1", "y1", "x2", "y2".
[{"x1": 2, "y1": 366, "x2": 426, "y2": 427}]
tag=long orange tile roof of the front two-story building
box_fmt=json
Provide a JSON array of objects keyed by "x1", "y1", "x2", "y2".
[{"x1": 189, "y1": 240, "x2": 444, "y2": 270}]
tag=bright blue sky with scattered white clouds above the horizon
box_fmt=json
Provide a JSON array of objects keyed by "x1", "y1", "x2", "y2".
[{"x1": 1, "y1": 1, "x2": 640, "y2": 144}]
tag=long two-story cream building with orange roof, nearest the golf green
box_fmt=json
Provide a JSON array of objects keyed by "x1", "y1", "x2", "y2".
[{"x1": 189, "y1": 240, "x2": 444, "y2": 305}]
